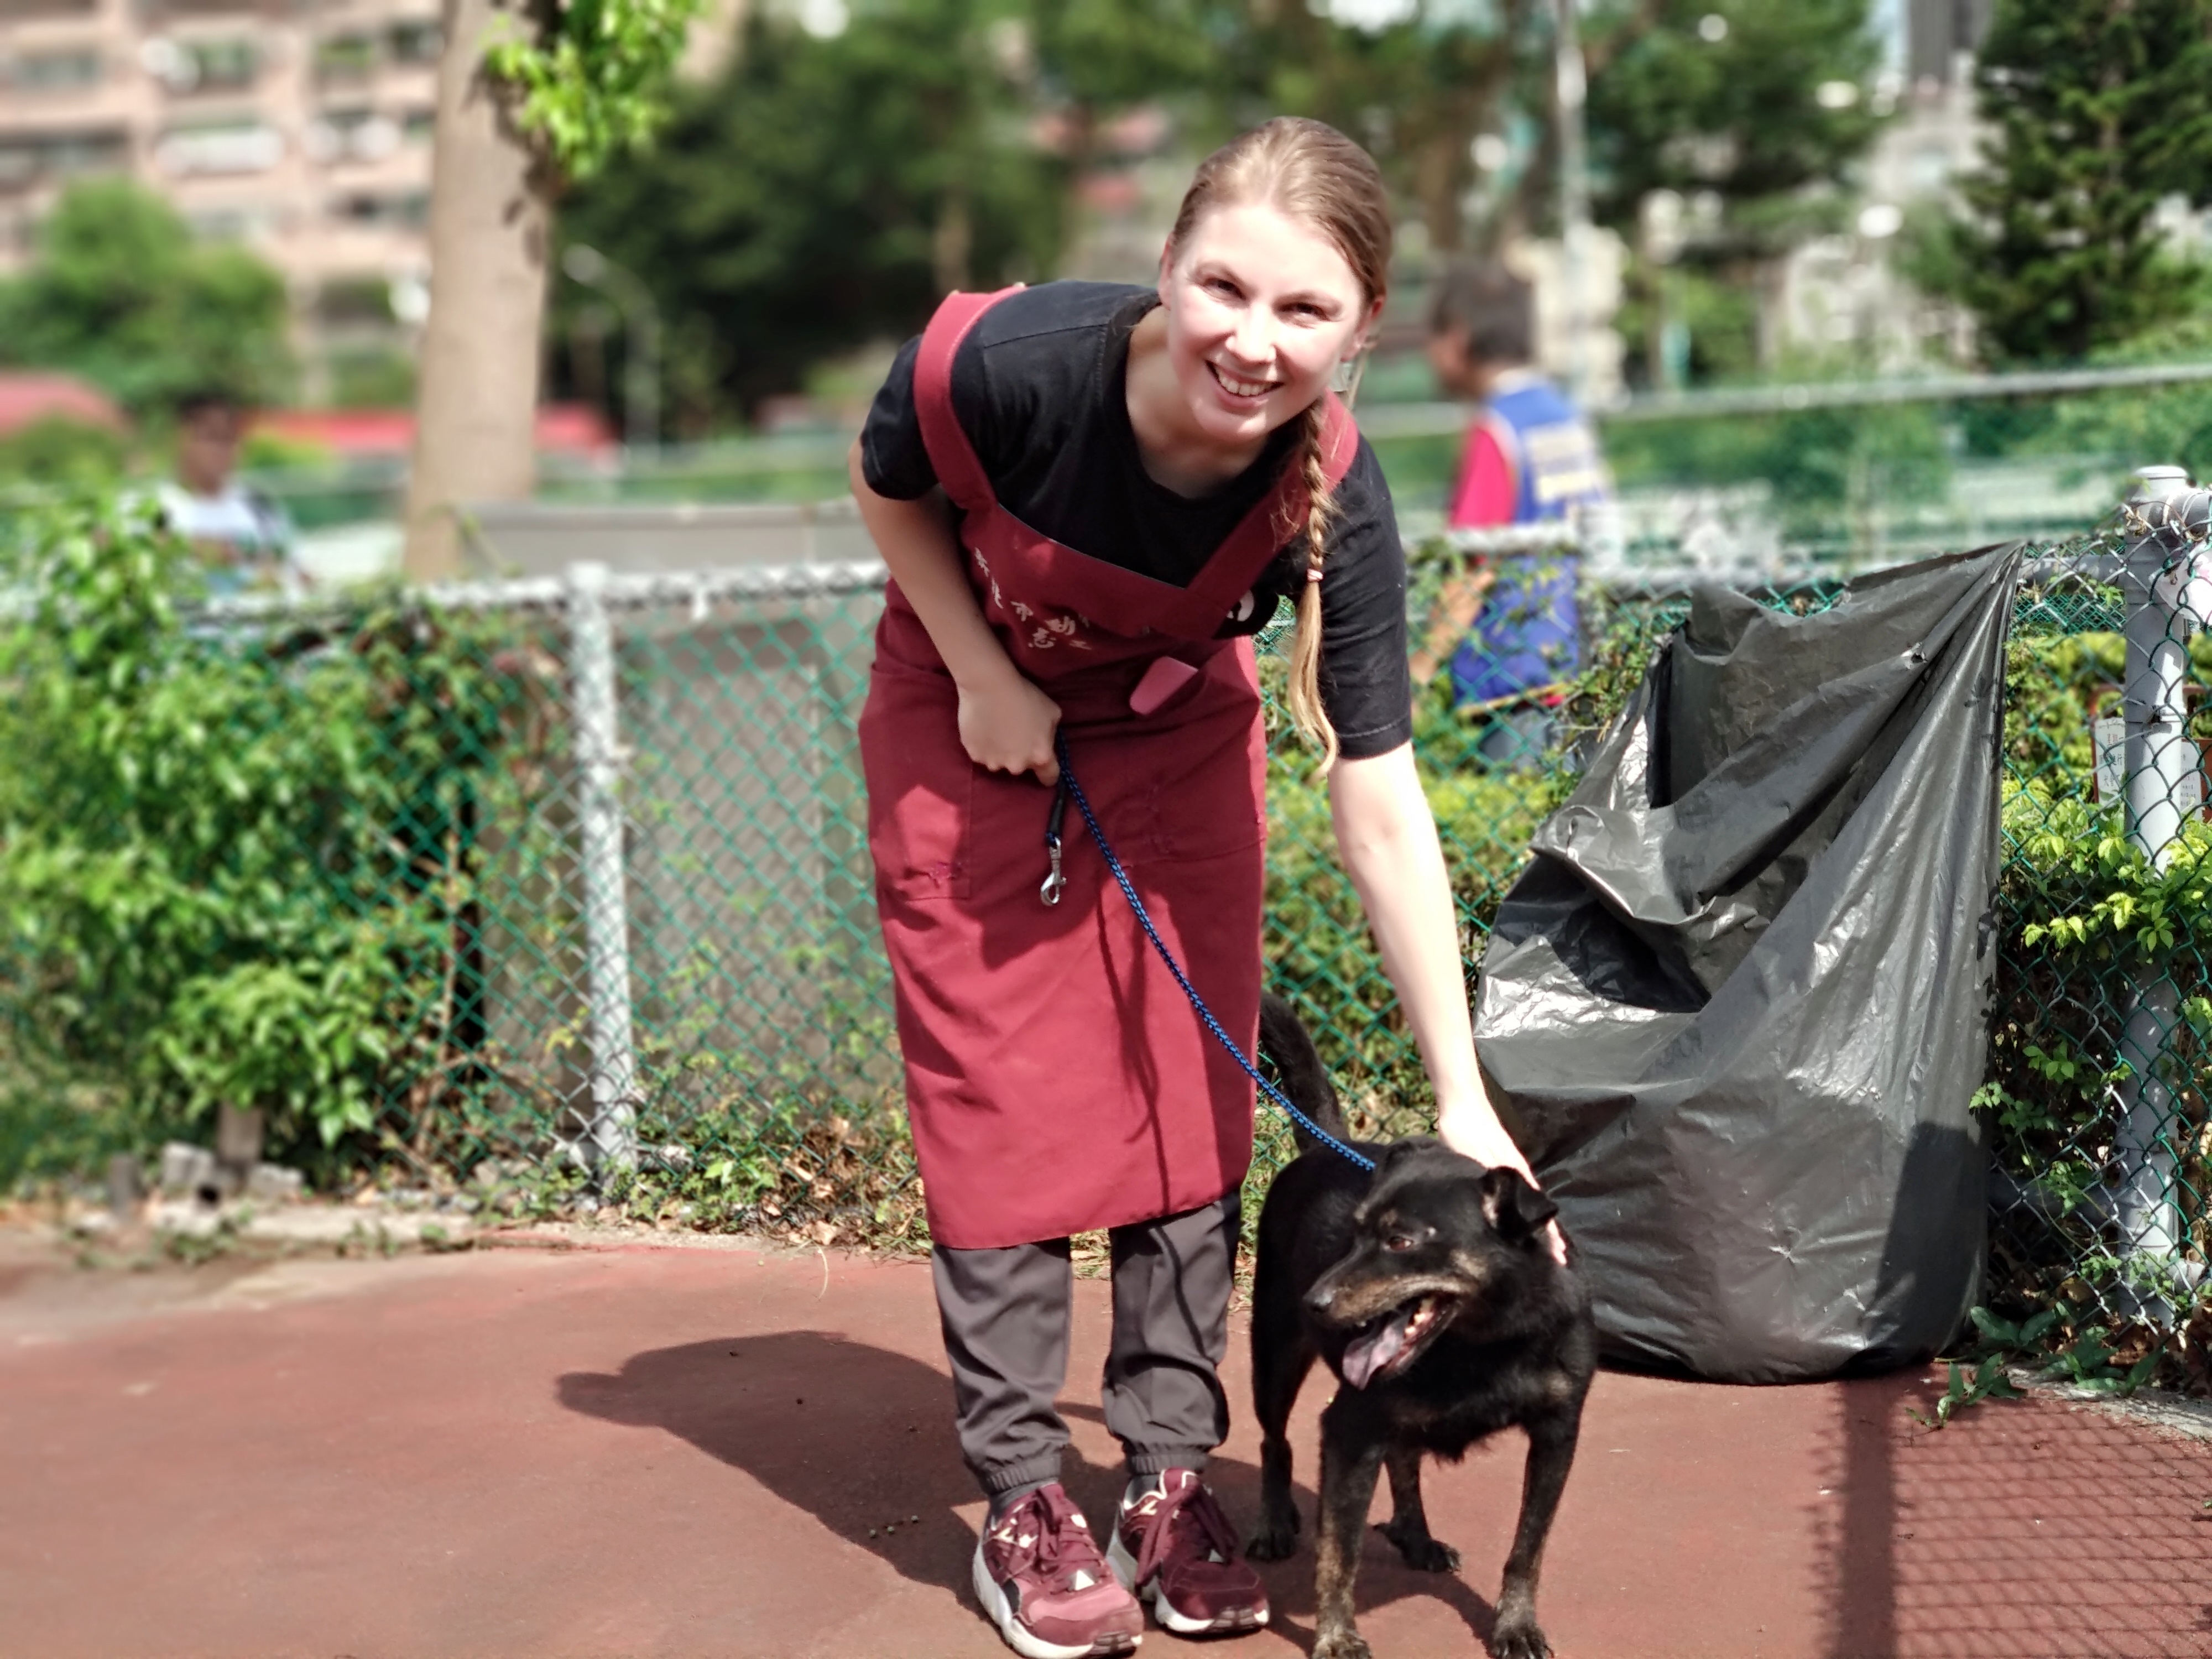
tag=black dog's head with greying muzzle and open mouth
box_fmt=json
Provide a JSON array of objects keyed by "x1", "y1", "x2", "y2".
[{"x1": 1305, "y1": 1139, "x2": 1559, "y2": 1389}]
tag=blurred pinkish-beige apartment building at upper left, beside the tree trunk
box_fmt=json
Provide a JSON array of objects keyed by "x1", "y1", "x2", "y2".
[{"x1": 0, "y1": 0, "x2": 440, "y2": 403}]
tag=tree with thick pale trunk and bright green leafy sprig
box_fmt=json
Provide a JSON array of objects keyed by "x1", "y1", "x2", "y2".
[{"x1": 405, "y1": 0, "x2": 699, "y2": 580}]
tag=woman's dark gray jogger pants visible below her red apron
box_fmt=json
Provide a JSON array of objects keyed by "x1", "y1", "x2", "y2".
[{"x1": 929, "y1": 1192, "x2": 1239, "y2": 1493}]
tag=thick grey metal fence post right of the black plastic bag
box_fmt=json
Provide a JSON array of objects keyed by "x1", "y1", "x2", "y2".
[{"x1": 2112, "y1": 467, "x2": 2199, "y2": 1263}]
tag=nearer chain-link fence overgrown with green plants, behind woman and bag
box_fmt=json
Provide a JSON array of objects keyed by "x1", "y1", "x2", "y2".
[{"x1": 0, "y1": 498, "x2": 2212, "y2": 1363}]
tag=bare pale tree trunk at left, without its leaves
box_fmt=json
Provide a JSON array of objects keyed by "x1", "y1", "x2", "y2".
[{"x1": 405, "y1": 0, "x2": 551, "y2": 582}]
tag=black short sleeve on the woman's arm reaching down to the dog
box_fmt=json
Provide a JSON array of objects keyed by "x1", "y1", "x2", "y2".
[{"x1": 1321, "y1": 438, "x2": 1413, "y2": 761}]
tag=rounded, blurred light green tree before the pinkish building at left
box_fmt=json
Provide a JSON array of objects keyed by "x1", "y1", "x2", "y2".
[{"x1": 0, "y1": 179, "x2": 292, "y2": 416}]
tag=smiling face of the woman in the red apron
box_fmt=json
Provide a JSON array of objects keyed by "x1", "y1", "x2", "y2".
[{"x1": 1159, "y1": 204, "x2": 1383, "y2": 447}]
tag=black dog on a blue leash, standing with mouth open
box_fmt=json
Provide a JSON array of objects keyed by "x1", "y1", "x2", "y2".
[{"x1": 1245, "y1": 998, "x2": 1597, "y2": 1659}]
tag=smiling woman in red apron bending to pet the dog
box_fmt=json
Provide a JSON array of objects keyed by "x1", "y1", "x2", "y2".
[{"x1": 852, "y1": 119, "x2": 1557, "y2": 1659}]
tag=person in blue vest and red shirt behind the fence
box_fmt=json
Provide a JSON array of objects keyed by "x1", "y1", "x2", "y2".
[{"x1": 1413, "y1": 261, "x2": 1613, "y2": 765}]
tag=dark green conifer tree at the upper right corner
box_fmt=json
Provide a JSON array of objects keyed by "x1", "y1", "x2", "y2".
[{"x1": 1958, "y1": 0, "x2": 2212, "y2": 363}]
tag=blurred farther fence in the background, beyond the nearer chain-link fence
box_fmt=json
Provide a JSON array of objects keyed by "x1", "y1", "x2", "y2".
[{"x1": 13, "y1": 354, "x2": 2212, "y2": 573}]
